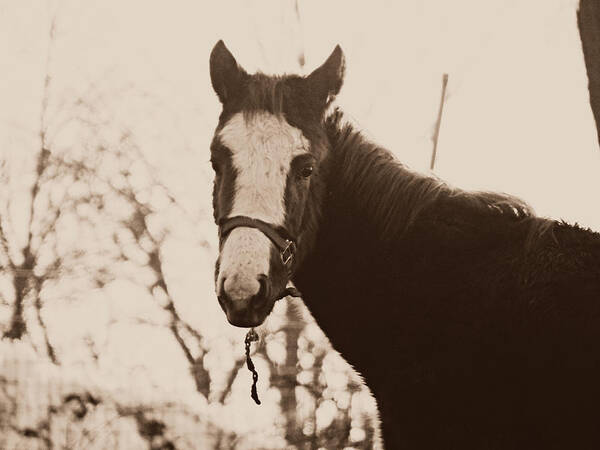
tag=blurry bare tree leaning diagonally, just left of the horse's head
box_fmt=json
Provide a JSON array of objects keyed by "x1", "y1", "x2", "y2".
[{"x1": 71, "y1": 132, "x2": 255, "y2": 412}]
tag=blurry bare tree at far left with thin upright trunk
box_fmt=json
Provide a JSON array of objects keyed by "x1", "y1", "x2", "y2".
[{"x1": 0, "y1": 7, "x2": 106, "y2": 364}]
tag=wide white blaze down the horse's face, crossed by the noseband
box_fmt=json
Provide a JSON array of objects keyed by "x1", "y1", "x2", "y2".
[{"x1": 217, "y1": 112, "x2": 309, "y2": 300}]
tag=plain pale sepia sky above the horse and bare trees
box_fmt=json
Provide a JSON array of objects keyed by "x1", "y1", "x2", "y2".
[{"x1": 0, "y1": 0, "x2": 600, "y2": 229}]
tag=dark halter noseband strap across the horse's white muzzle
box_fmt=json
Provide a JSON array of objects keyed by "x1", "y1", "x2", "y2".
[{"x1": 219, "y1": 216, "x2": 296, "y2": 271}]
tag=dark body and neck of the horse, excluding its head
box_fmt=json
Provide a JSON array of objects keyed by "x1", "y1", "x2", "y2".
[{"x1": 294, "y1": 112, "x2": 600, "y2": 449}]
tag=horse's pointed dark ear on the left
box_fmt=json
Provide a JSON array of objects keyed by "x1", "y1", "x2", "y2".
[{"x1": 210, "y1": 40, "x2": 247, "y2": 104}]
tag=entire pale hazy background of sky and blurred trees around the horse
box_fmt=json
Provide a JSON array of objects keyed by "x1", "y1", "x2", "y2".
[{"x1": 0, "y1": 0, "x2": 600, "y2": 448}]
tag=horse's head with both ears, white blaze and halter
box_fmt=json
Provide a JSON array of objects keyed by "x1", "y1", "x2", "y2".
[{"x1": 210, "y1": 41, "x2": 344, "y2": 327}]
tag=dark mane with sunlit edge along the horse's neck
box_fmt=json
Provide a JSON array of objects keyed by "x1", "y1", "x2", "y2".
[{"x1": 325, "y1": 109, "x2": 554, "y2": 243}]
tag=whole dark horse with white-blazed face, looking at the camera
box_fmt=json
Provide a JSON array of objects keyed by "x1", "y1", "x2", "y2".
[{"x1": 209, "y1": 41, "x2": 600, "y2": 449}]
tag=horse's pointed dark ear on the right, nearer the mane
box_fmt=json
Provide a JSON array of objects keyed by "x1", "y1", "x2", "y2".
[{"x1": 306, "y1": 45, "x2": 346, "y2": 107}]
